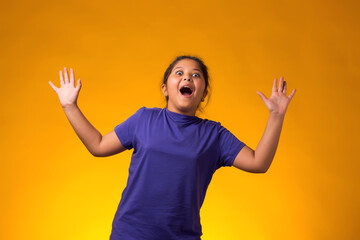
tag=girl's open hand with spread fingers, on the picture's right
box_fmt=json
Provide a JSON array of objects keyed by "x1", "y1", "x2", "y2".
[{"x1": 256, "y1": 77, "x2": 296, "y2": 115}]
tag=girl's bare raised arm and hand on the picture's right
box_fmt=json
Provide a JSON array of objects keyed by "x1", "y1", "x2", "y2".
[{"x1": 233, "y1": 77, "x2": 296, "y2": 173}]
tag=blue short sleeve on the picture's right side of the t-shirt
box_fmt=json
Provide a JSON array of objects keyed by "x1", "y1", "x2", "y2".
[{"x1": 218, "y1": 123, "x2": 245, "y2": 168}]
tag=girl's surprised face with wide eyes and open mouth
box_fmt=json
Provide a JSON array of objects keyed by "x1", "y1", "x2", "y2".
[{"x1": 161, "y1": 59, "x2": 207, "y2": 116}]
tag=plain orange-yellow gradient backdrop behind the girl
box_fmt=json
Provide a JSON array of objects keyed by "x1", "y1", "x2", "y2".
[{"x1": 0, "y1": 0, "x2": 360, "y2": 240}]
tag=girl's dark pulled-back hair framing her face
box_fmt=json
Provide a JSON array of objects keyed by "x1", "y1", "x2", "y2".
[{"x1": 163, "y1": 55, "x2": 210, "y2": 112}]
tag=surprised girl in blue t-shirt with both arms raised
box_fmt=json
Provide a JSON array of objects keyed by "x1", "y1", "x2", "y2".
[{"x1": 49, "y1": 56, "x2": 295, "y2": 240}]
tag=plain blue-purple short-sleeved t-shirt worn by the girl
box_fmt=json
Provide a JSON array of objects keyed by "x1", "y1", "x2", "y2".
[{"x1": 110, "y1": 107, "x2": 245, "y2": 240}]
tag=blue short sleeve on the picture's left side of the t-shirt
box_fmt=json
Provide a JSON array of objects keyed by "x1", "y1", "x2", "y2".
[{"x1": 114, "y1": 107, "x2": 145, "y2": 150}]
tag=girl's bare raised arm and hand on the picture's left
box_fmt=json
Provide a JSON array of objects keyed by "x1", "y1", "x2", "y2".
[{"x1": 49, "y1": 68, "x2": 126, "y2": 157}]
